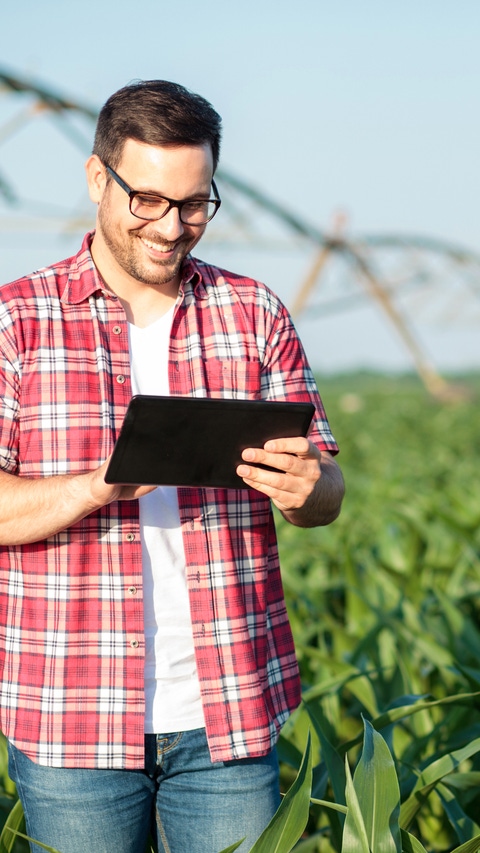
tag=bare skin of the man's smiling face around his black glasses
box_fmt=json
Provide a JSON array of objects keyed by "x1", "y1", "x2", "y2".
[{"x1": 93, "y1": 139, "x2": 213, "y2": 291}]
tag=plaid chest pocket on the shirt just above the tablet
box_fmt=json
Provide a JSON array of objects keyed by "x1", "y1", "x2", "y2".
[{"x1": 203, "y1": 358, "x2": 261, "y2": 400}]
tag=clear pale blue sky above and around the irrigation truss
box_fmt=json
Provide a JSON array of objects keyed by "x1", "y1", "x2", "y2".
[{"x1": 0, "y1": 0, "x2": 480, "y2": 369}]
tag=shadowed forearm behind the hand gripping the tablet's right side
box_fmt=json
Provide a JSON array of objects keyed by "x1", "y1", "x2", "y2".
[{"x1": 281, "y1": 451, "x2": 345, "y2": 527}]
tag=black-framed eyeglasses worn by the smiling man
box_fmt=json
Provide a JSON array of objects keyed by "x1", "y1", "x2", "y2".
[{"x1": 105, "y1": 164, "x2": 222, "y2": 225}]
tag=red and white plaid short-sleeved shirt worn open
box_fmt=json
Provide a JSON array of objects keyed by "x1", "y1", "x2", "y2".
[{"x1": 0, "y1": 235, "x2": 337, "y2": 769}]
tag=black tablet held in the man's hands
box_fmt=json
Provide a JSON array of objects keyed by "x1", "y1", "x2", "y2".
[{"x1": 105, "y1": 394, "x2": 315, "y2": 489}]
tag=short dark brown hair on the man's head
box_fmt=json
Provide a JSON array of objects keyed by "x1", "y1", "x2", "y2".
[{"x1": 93, "y1": 80, "x2": 222, "y2": 171}]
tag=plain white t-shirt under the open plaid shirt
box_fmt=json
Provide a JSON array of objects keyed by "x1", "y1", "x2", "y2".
[{"x1": 129, "y1": 307, "x2": 205, "y2": 733}]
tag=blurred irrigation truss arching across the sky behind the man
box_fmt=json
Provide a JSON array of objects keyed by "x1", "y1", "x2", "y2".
[{"x1": 0, "y1": 69, "x2": 480, "y2": 398}]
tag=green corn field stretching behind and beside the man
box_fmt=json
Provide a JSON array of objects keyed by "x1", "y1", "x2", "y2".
[{"x1": 0, "y1": 375, "x2": 480, "y2": 853}]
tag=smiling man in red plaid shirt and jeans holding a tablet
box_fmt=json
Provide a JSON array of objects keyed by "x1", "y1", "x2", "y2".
[{"x1": 0, "y1": 81, "x2": 343, "y2": 853}]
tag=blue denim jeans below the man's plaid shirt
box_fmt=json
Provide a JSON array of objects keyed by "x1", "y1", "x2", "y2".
[{"x1": 8, "y1": 729, "x2": 280, "y2": 853}]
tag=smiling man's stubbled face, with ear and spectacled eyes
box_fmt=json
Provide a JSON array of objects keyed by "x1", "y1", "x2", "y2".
[{"x1": 87, "y1": 139, "x2": 216, "y2": 312}]
